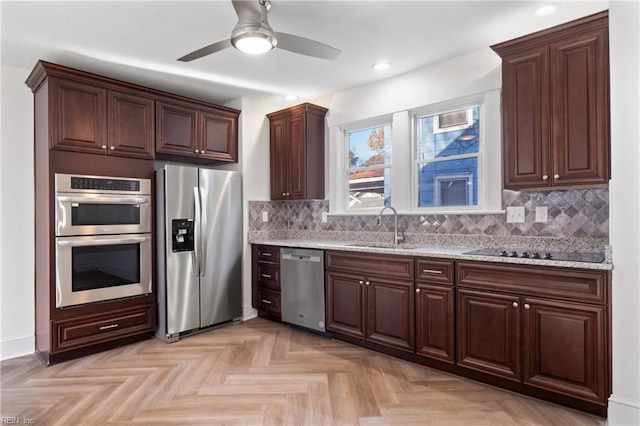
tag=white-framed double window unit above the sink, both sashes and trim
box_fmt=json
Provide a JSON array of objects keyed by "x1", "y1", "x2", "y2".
[{"x1": 327, "y1": 89, "x2": 503, "y2": 215}]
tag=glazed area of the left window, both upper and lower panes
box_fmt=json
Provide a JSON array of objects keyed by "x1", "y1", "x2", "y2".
[{"x1": 346, "y1": 124, "x2": 391, "y2": 210}]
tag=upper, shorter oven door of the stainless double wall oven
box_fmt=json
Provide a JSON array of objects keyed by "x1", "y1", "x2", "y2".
[{"x1": 56, "y1": 193, "x2": 151, "y2": 236}]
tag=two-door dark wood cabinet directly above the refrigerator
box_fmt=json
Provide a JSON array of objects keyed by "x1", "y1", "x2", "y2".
[{"x1": 156, "y1": 100, "x2": 240, "y2": 163}]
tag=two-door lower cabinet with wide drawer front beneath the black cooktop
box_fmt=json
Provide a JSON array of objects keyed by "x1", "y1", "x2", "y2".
[{"x1": 457, "y1": 261, "x2": 611, "y2": 410}]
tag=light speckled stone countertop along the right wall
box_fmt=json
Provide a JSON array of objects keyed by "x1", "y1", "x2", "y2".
[{"x1": 249, "y1": 235, "x2": 613, "y2": 270}]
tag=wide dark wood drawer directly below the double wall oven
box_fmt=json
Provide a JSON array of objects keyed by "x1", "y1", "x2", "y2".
[{"x1": 51, "y1": 305, "x2": 155, "y2": 353}]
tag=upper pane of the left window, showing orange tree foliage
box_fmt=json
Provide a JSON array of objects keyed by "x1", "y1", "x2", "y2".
[{"x1": 348, "y1": 126, "x2": 391, "y2": 169}]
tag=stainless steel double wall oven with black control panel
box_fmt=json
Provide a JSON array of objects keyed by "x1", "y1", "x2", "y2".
[{"x1": 55, "y1": 174, "x2": 152, "y2": 308}]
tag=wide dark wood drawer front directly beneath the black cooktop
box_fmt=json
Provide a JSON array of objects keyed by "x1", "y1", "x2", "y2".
[{"x1": 456, "y1": 261, "x2": 609, "y2": 303}]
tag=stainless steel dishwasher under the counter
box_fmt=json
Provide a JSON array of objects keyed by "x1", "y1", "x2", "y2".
[{"x1": 280, "y1": 248, "x2": 326, "y2": 333}]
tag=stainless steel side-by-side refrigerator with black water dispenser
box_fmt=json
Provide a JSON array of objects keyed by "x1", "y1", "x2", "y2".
[{"x1": 156, "y1": 165, "x2": 242, "y2": 342}]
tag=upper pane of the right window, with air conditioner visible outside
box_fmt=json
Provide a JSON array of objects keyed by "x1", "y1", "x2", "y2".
[{"x1": 418, "y1": 106, "x2": 480, "y2": 160}]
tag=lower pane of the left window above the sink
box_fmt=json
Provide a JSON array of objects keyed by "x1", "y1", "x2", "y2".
[{"x1": 348, "y1": 167, "x2": 391, "y2": 209}]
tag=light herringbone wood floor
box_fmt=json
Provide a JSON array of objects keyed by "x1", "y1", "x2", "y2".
[{"x1": 0, "y1": 318, "x2": 606, "y2": 426}]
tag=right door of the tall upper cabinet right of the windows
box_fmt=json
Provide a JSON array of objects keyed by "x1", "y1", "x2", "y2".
[{"x1": 550, "y1": 29, "x2": 609, "y2": 186}]
